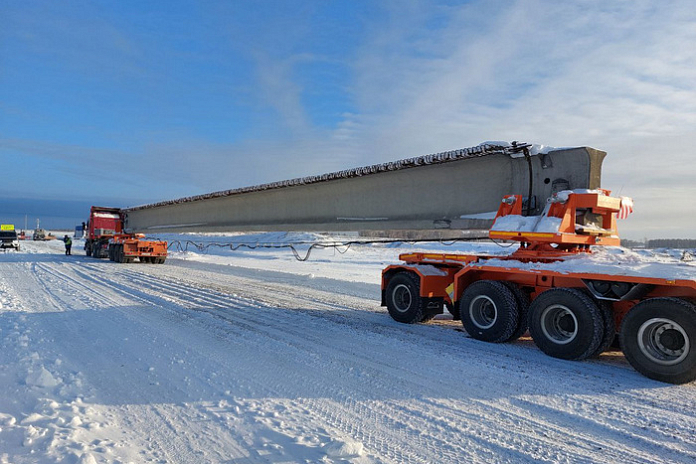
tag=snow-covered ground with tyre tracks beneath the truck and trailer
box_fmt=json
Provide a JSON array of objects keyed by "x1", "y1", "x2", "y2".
[{"x1": 0, "y1": 234, "x2": 696, "y2": 464}]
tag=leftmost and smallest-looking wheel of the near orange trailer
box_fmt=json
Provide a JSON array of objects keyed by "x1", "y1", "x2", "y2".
[{"x1": 385, "y1": 272, "x2": 426, "y2": 324}]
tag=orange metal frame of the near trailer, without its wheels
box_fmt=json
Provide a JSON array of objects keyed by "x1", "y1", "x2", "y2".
[{"x1": 382, "y1": 191, "x2": 696, "y2": 327}]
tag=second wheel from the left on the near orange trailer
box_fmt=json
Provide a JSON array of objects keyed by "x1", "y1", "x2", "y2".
[{"x1": 459, "y1": 280, "x2": 519, "y2": 343}]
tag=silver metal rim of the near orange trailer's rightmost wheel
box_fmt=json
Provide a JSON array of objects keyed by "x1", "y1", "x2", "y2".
[{"x1": 638, "y1": 318, "x2": 691, "y2": 366}]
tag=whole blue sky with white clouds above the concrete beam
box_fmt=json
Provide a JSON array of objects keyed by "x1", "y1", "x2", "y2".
[{"x1": 0, "y1": 0, "x2": 696, "y2": 238}]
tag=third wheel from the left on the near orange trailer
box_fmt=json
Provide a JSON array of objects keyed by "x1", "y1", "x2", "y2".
[{"x1": 529, "y1": 288, "x2": 604, "y2": 360}]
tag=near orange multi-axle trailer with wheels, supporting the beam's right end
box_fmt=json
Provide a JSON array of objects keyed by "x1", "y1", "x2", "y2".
[{"x1": 382, "y1": 190, "x2": 696, "y2": 384}]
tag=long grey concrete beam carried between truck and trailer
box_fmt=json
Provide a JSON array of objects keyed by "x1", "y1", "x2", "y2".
[{"x1": 125, "y1": 144, "x2": 606, "y2": 233}]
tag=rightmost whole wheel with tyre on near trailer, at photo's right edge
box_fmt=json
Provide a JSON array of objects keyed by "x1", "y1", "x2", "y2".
[{"x1": 619, "y1": 298, "x2": 696, "y2": 384}]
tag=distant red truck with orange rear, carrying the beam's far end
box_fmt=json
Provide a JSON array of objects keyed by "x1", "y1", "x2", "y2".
[{"x1": 85, "y1": 206, "x2": 167, "y2": 264}]
